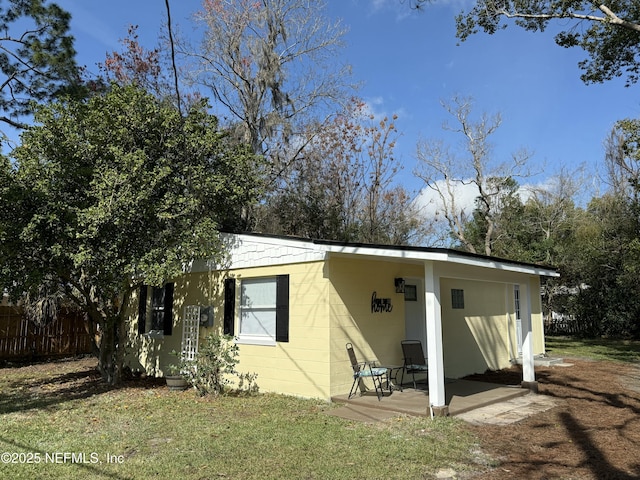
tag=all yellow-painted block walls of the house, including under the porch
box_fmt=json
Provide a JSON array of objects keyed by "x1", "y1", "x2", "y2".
[{"x1": 127, "y1": 233, "x2": 544, "y2": 399}]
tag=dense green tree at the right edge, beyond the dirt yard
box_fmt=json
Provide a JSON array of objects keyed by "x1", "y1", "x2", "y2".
[{"x1": 572, "y1": 119, "x2": 640, "y2": 338}]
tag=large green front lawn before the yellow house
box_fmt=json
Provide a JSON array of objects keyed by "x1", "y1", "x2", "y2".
[{"x1": 0, "y1": 362, "x2": 478, "y2": 479}]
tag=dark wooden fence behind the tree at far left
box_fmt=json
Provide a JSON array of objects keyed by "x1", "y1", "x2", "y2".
[{"x1": 0, "y1": 305, "x2": 91, "y2": 360}]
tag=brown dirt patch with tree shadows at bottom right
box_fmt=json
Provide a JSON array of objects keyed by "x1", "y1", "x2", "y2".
[{"x1": 470, "y1": 359, "x2": 640, "y2": 480}]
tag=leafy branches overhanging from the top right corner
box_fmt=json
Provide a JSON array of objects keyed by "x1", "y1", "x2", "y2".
[{"x1": 413, "y1": 0, "x2": 640, "y2": 86}]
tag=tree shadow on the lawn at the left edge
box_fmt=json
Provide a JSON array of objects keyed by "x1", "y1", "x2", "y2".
[{"x1": 0, "y1": 361, "x2": 165, "y2": 414}]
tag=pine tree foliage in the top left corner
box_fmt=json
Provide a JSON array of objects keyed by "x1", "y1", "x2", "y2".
[{"x1": 0, "y1": 0, "x2": 78, "y2": 128}]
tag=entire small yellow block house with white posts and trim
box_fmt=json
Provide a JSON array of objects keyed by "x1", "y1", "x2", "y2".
[{"x1": 128, "y1": 234, "x2": 558, "y2": 414}]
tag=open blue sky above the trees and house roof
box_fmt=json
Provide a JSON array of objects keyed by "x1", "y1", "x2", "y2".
[{"x1": 57, "y1": 0, "x2": 640, "y2": 204}]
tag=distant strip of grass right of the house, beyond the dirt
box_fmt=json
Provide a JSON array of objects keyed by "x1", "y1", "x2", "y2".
[{"x1": 546, "y1": 337, "x2": 640, "y2": 363}]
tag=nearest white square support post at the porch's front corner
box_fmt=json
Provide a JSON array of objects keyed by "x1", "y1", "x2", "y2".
[{"x1": 424, "y1": 262, "x2": 449, "y2": 417}]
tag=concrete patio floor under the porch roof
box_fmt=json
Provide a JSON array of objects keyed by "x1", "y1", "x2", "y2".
[{"x1": 331, "y1": 379, "x2": 530, "y2": 417}]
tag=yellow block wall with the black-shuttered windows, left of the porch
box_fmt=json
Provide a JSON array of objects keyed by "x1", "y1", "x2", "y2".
[{"x1": 127, "y1": 262, "x2": 330, "y2": 398}]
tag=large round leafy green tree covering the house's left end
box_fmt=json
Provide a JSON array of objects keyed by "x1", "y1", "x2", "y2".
[{"x1": 0, "y1": 85, "x2": 257, "y2": 384}]
